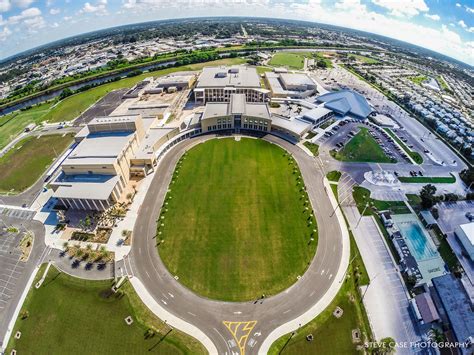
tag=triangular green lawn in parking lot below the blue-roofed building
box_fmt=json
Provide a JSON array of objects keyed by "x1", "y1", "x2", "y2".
[{"x1": 331, "y1": 127, "x2": 394, "y2": 163}]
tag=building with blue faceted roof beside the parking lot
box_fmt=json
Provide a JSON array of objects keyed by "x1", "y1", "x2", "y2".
[{"x1": 316, "y1": 90, "x2": 372, "y2": 119}]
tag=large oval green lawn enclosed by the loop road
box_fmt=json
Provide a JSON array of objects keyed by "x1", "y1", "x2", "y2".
[{"x1": 158, "y1": 138, "x2": 317, "y2": 301}]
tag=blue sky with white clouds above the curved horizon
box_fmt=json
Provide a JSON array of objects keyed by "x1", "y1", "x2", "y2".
[{"x1": 0, "y1": 0, "x2": 474, "y2": 65}]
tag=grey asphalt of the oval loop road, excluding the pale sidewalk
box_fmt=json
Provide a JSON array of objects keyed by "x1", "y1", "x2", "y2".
[{"x1": 129, "y1": 135, "x2": 342, "y2": 354}]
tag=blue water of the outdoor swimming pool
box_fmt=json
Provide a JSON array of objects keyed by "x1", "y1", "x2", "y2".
[{"x1": 397, "y1": 222, "x2": 438, "y2": 260}]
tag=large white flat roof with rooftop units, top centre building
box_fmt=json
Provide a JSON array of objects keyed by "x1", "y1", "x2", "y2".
[{"x1": 196, "y1": 65, "x2": 260, "y2": 88}]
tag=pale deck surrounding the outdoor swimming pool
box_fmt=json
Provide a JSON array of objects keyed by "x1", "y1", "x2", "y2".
[{"x1": 392, "y1": 213, "x2": 447, "y2": 285}]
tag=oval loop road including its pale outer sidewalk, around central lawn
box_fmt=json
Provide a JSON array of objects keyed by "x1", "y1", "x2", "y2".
[{"x1": 125, "y1": 135, "x2": 349, "y2": 354}]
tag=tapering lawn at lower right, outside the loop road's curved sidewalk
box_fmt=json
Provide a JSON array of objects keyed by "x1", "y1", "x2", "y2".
[{"x1": 269, "y1": 185, "x2": 371, "y2": 355}]
